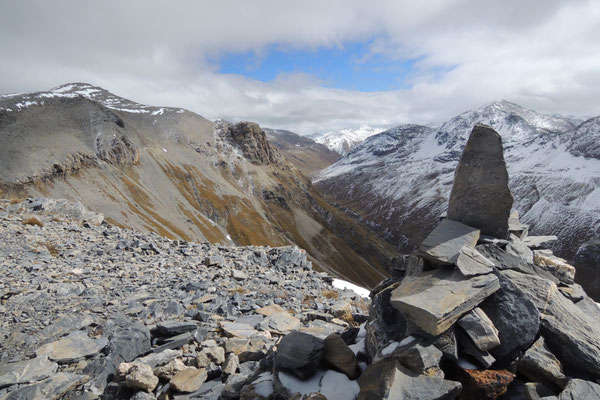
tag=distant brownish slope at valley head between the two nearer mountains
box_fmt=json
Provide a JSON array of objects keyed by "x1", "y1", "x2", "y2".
[{"x1": 264, "y1": 128, "x2": 340, "y2": 176}]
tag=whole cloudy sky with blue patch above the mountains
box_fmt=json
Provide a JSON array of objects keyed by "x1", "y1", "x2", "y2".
[{"x1": 0, "y1": 0, "x2": 600, "y2": 134}]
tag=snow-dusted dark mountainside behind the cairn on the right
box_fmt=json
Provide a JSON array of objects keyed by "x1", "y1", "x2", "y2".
[{"x1": 314, "y1": 101, "x2": 600, "y2": 298}]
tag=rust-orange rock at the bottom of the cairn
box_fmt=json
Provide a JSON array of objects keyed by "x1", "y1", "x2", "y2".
[{"x1": 460, "y1": 369, "x2": 515, "y2": 400}]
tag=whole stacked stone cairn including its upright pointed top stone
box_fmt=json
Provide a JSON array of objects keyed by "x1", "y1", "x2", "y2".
[{"x1": 358, "y1": 125, "x2": 600, "y2": 400}]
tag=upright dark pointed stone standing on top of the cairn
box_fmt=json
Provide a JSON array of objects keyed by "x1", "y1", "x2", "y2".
[{"x1": 448, "y1": 124, "x2": 513, "y2": 239}]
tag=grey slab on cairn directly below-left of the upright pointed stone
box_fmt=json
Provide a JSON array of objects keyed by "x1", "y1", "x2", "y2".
[{"x1": 417, "y1": 219, "x2": 480, "y2": 264}]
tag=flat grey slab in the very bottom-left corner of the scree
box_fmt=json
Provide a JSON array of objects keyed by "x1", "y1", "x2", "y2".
[{"x1": 3, "y1": 372, "x2": 87, "y2": 400}]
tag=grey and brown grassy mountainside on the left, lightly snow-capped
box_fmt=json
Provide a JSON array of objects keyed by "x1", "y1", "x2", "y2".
[{"x1": 0, "y1": 83, "x2": 394, "y2": 287}]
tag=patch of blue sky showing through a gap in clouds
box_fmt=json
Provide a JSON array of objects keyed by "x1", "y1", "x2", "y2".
[{"x1": 213, "y1": 42, "x2": 418, "y2": 92}]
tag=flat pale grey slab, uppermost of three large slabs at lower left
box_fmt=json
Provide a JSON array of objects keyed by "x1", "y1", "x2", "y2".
[{"x1": 36, "y1": 331, "x2": 108, "y2": 363}]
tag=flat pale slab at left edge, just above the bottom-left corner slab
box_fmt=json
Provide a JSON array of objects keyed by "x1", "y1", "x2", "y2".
[{"x1": 0, "y1": 356, "x2": 58, "y2": 388}]
